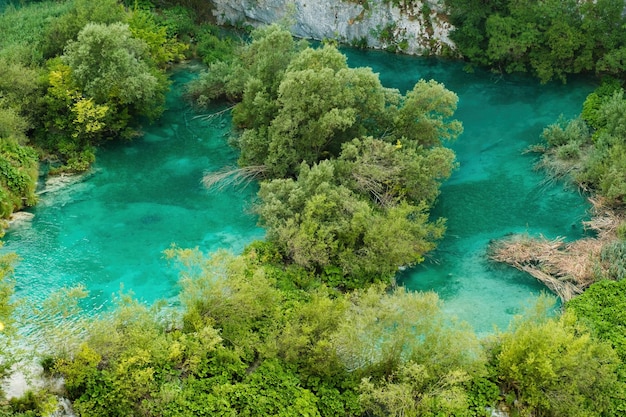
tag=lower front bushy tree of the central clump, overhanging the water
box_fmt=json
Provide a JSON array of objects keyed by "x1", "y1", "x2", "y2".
[{"x1": 257, "y1": 161, "x2": 443, "y2": 288}]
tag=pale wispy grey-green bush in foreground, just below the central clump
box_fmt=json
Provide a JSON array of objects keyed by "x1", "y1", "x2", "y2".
[{"x1": 334, "y1": 285, "x2": 483, "y2": 376}]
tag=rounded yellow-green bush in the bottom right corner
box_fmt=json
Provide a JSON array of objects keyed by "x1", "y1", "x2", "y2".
[{"x1": 491, "y1": 296, "x2": 624, "y2": 416}]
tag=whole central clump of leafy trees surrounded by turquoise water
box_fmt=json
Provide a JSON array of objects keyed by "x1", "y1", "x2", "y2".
[{"x1": 192, "y1": 25, "x2": 462, "y2": 289}]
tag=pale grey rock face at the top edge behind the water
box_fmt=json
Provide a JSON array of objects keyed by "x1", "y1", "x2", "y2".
[{"x1": 213, "y1": 0, "x2": 454, "y2": 55}]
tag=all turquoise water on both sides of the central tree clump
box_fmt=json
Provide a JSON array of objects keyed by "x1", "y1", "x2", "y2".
[{"x1": 5, "y1": 50, "x2": 592, "y2": 332}]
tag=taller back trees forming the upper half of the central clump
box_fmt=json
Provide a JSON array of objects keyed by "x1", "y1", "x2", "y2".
[{"x1": 234, "y1": 41, "x2": 462, "y2": 178}]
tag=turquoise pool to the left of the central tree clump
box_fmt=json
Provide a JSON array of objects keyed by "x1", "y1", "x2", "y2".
[{"x1": 3, "y1": 65, "x2": 264, "y2": 307}]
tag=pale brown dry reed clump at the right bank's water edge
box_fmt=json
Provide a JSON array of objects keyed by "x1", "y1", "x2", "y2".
[{"x1": 490, "y1": 199, "x2": 624, "y2": 301}]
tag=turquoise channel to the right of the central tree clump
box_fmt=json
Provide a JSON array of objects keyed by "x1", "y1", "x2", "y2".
[{"x1": 342, "y1": 51, "x2": 593, "y2": 332}]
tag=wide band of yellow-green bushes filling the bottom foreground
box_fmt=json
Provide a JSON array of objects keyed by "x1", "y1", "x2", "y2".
[{"x1": 48, "y1": 243, "x2": 626, "y2": 417}]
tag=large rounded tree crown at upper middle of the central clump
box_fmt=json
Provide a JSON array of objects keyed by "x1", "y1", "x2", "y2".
[{"x1": 258, "y1": 52, "x2": 385, "y2": 177}]
